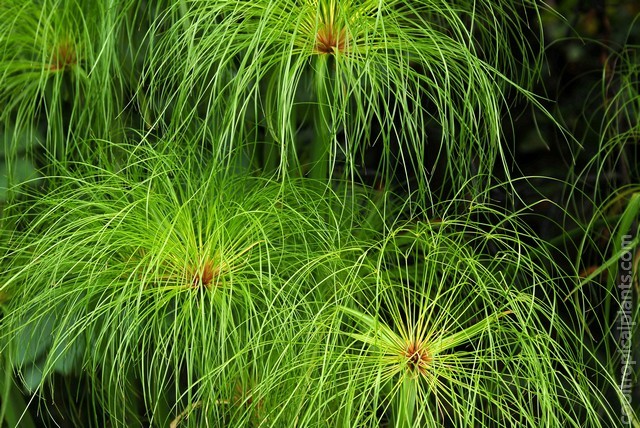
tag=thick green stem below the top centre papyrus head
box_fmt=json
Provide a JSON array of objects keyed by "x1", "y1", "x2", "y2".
[{"x1": 309, "y1": 55, "x2": 332, "y2": 181}]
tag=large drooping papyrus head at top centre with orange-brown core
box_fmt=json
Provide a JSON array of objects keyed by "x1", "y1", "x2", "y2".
[{"x1": 144, "y1": 0, "x2": 540, "y2": 195}]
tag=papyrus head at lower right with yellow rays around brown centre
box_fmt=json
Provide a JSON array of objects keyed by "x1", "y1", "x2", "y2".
[{"x1": 264, "y1": 209, "x2": 618, "y2": 427}]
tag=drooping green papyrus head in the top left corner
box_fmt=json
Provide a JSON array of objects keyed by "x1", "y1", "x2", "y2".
[{"x1": 0, "y1": 0, "x2": 142, "y2": 160}]
